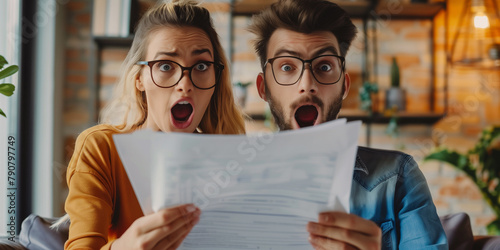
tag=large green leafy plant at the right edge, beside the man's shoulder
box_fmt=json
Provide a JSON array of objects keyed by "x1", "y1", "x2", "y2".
[{"x1": 425, "y1": 126, "x2": 500, "y2": 235}]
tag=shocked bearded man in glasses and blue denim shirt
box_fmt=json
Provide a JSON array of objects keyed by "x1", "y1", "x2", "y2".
[{"x1": 250, "y1": 0, "x2": 448, "y2": 249}]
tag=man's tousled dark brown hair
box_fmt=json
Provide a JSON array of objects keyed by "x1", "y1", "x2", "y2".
[{"x1": 249, "y1": 0, "x2": 357, "y2": 67}]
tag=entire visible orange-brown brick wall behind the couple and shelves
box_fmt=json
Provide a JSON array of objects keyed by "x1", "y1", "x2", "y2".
[{"x1": 63, "y1": 0, "x2": 500, "y2": 234}]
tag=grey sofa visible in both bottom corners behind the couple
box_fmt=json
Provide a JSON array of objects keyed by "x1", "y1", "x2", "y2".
[{"x1": 0, "y1": 213, "x2": 500, "y2": 250}]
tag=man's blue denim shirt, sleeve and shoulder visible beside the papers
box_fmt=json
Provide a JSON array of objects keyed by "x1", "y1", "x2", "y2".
[{"x1": 350, "y1": 147, "x2": 448, "y2": 249}]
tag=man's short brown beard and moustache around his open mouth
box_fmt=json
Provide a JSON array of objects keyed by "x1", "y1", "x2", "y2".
[{"x1": 264, "y1": 83, "x2": 345, "y2": 130}]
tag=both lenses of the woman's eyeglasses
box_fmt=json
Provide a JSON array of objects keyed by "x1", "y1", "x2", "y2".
[{"x1": 151, "y1": 61, "x2": 216, "y2": 88}]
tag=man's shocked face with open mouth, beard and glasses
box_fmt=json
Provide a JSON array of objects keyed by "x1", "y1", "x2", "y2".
[{"x1": 257, "y1": 29, "x2": 350, "y2": 130}]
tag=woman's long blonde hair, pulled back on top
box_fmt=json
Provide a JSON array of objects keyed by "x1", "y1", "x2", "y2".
[{"x1": 100, "y1": 0, "x2": 245, "y2": 134}]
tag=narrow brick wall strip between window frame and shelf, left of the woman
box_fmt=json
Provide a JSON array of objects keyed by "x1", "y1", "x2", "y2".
[{"x1": 58, "y1": 0, "x2": 95, "y2": 213}]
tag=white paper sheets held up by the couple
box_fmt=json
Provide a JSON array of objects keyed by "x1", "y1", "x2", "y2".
[{"x1": 114, "y1": 120, "x2": 361, "y2": 249}]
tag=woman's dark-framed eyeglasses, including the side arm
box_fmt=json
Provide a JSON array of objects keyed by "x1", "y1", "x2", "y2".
[{"x1": 136, "y1": 60, "x2": 224, "y2": 89}]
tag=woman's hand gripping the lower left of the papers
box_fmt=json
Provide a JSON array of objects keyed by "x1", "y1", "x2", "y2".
[{"x1": 111, "y1": 204, "x2": 201, "y2": 249}]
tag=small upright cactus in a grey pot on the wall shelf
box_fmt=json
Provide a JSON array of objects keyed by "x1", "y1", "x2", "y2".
[{"x1": 385, "y1": 57, "x2": 406, "y2": 111}]
